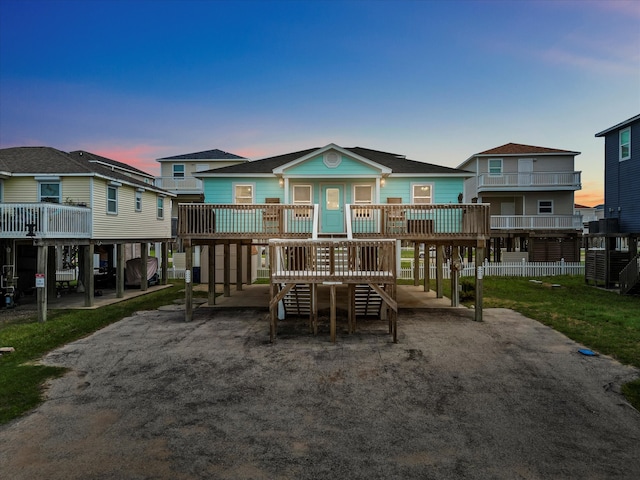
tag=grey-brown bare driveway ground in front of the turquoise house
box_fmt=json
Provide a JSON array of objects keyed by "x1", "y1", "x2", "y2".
[{"x1": 0, "y1": 307, "x2": 640, "y2": 480}]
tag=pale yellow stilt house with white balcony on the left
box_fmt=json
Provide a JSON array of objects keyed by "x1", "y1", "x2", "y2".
[{"x1": 0, "y1": 147, "x2": 173, "y2": 314}]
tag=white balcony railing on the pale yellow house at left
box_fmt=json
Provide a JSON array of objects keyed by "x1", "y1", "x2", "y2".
[{"x1": 0, "y1": 203, "x2": 91, "y2": 238}]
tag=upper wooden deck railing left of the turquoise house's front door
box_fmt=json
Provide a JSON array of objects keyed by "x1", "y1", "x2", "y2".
[{"x1": 178, "y1": 203, "x2": 318, "y2": 239}]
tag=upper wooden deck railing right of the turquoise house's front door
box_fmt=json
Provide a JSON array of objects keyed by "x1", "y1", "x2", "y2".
[{"x1": 347, "y1": 203, "x2": 490, "y2": 240}]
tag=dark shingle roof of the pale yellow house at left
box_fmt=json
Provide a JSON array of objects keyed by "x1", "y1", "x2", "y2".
[{"x1": 0, "y1": 147, "x2": 175, "y2": 197}]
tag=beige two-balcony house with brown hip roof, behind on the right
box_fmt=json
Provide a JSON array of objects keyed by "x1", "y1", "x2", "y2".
[{"x1": 458, "y1": 143, "x2": 583, "y2": 262}]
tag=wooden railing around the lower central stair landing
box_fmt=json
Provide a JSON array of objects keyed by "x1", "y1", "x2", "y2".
[{"x1": 269, "y1": 239, "x2": 396, "y2": 283}]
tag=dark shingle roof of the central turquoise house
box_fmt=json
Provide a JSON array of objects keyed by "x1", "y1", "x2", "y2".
[{"x1": 197, "y1": 144, "x2": 469, "y2": 177}]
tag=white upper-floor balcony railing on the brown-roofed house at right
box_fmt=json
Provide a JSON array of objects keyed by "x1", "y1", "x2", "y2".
[{"x1": 478, "y1": 172, "x2": 580, "y2": 190}]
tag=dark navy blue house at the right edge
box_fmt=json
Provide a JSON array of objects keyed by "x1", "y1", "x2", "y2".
[{"x1": 585, "y1": 115, "x2": 640, "y2": 293}]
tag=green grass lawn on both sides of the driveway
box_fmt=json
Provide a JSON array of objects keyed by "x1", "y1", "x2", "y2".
[{"x1": 0, "y1": 276, "x2": 640, "y2": 424}]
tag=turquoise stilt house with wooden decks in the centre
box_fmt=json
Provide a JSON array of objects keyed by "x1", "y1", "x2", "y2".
[{"x1": 178, "y1": 144, "x2": 489, "y2": 336}]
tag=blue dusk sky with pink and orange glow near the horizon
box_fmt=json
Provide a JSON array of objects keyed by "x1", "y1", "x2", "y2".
[{"x1": 0, "y1": 0, "x2": 640, "y2": 206}]
